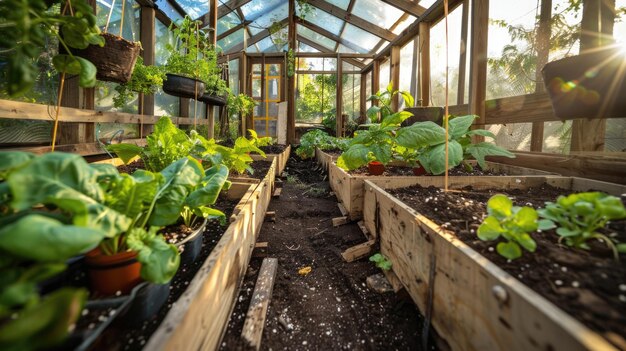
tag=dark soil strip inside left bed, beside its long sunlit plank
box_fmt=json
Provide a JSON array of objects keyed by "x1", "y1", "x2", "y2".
[{"x1": 92, "y1": 198, "x2": 239, "y2": 351}]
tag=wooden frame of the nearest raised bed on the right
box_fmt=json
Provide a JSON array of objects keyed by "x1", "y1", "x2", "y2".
[{"x1": 363, "y1": 176, "x2": 626, "y2": 350}]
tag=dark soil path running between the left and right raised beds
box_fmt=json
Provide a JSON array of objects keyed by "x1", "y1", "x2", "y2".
[{"x1": 221, "y1": 157, "x2": 432, "y2": 350}]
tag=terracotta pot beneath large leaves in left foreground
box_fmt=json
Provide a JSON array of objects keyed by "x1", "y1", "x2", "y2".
[{"x1": 85, "y1": 248, "x2": 142, "y2": 296}]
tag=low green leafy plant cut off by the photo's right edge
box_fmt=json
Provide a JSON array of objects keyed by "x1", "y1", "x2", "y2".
[{"x1": 538, "y1": 192, "x2": 626, "y2": 258}]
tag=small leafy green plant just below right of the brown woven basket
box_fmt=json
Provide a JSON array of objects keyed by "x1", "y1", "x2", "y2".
[{"x1": 113, "y1": 57, "x2": 165, "y2": 108}]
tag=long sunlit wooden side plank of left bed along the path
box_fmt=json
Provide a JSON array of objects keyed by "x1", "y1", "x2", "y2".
[{"x1": 146, "y1": 161, "x2": 274, "y2": 350}]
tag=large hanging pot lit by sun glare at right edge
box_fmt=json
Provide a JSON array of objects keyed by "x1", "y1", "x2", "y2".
[{"x1": 541, "y1": 47, "x2": 626, "y2": 119}]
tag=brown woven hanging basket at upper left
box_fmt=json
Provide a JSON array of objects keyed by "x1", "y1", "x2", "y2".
[{"x1": 73, "y1": 33, "x2": 141, "y2": 83}]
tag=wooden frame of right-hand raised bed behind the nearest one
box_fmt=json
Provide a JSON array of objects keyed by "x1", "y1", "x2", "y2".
[{"x1": 329, "y1": 161, "x2": 551, "y2": 220}]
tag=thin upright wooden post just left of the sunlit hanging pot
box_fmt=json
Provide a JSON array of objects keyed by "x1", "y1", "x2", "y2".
[{"x1": 530, "y1": 0, "x2": 552, "y2": 152}]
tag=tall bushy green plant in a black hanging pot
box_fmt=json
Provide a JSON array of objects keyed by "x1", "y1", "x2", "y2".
[{"x1": 163, "y1": 16, "x2": 212, "y2": 99}]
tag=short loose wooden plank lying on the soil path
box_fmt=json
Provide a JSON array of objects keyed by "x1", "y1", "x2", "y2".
[{"x1": 241, "y1": 258, "x2": 278, "y2": 350}]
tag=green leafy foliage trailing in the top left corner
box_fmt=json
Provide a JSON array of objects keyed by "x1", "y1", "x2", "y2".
[{"x1": 0, "y1": 0, "x2": 104, "y2": 96}]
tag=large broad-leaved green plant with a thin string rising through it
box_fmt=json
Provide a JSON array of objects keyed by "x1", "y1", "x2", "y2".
[{"x1": 396, "y1": 115, "x2": 515, "y2": 175}]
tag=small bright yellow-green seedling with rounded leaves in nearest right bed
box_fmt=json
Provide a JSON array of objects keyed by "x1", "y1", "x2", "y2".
[{"x1": 477, "y1": 194, "x2": 553, "y2": 260}]
